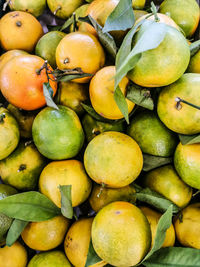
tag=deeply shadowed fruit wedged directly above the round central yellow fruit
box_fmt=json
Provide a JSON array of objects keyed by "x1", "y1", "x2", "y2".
[{"x1": 82, "y1": 114, "x2": 124, "y2": 143}]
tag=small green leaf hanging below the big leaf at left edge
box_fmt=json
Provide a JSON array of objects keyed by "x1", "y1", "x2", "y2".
[{"x1": 6, "y1": 219, "x2": 28, "y2": 247}]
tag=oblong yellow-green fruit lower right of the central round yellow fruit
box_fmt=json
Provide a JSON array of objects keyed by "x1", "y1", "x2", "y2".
[{"x1": 143, "y1": 165, "x2": 192, "y2": 208}]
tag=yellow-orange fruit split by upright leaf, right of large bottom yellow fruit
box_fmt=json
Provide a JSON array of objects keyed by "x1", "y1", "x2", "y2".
[{"x1": 140, "y1": 207, "x2": 176, "y2": 248}]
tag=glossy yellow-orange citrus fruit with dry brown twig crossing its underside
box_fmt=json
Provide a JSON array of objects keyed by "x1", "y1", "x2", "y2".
[{"x1": 56, "y1": 32, "x2": 105, "y2": 83}]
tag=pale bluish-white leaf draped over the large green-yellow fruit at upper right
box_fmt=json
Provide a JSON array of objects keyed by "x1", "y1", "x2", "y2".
[{"x1": 115, "y1": 20, "x2": 167, "y2": 87}]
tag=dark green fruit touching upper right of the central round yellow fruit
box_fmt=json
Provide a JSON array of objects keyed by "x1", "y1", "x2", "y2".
[{"x1": 128, "y1": 111, "x2": 178, "y2": 157}]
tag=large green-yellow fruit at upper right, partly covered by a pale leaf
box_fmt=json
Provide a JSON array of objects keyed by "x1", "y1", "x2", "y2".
[{"x1": 128, "y1": 20, "x2": 190, "y2": 87}]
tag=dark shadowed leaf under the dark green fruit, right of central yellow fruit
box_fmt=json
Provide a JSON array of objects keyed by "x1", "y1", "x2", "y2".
[{"x1": 143, "y1": 154, "x2": 173, "y2": 172}]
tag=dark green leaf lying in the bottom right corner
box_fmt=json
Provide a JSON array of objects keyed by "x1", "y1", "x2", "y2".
[{"x1": 143, "y1": 247, "x2": 200, "y2": 267}]
